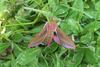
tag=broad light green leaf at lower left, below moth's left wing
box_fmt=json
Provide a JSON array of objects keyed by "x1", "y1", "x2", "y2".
[{"x1": 16, "y1": 48, "x2": 40, "y2": 65}]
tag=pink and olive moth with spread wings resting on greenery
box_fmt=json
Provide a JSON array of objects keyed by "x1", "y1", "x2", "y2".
[{"x1": 29, "y1": 20, "x2": 76, "y2": 49}]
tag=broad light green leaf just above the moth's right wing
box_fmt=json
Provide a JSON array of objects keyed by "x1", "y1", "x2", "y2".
[{"x1": 60, "y1": 19, "x2": 82, "y2": 34}]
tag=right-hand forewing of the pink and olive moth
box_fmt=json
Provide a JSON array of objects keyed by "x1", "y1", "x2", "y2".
[{"x1": 57, "y1": 28, "x2": 76, "y2": 49}]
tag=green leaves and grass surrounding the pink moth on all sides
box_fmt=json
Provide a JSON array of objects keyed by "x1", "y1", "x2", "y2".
[{"x1": 0, "y1": 0, "x2": 100, "y2": 67}]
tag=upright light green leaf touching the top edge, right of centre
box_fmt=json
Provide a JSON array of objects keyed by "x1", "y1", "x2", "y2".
[{"x1": 69, "y1": 0, "x2": 84, "y2": 20}]
